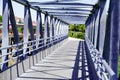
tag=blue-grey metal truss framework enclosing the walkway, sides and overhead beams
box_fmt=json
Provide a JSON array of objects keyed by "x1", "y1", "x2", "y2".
[{"x1": 0, "y1": 0, "x2": 120, "y2": 80}]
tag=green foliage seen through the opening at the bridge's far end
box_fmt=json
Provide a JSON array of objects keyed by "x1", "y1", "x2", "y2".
[{"x1": 69, "y1": 24, "x2": 85, "y2": 39}]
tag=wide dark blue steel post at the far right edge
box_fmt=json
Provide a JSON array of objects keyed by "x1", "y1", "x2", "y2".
[{"x1": 108, "y1": 0, "x2": 120, "y2": 80}]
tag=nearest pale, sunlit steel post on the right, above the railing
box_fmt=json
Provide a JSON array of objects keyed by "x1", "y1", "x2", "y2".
[{"x1": 97, "y1": 0, "x2": 107, "y2": 54}]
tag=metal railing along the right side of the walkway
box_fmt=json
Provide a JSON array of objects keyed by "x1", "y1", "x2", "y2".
[{"x1": 86, "y1": 37, "x2": 116, "y2": 80}]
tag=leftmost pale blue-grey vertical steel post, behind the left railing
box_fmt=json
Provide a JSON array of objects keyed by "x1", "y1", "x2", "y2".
[{"x1": 1, "y1": 0, "x2": 9, "y2": 70}]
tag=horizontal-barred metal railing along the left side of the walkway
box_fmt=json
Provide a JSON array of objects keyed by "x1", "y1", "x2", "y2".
[{"x1": 0, "y1": 35, "x2": 68, "y2": 72}]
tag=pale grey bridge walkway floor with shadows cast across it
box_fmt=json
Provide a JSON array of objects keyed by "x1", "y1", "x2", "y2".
[{"x1": 16, "y1": 39, "x2": 89, "y2": 80}]
